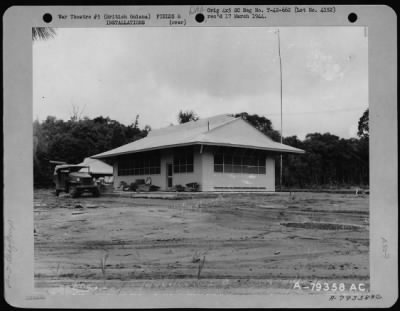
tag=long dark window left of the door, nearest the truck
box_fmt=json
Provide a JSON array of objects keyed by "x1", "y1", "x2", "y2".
[{"x1": 118, "y1": 152, "x2": 161, "y2": 176}]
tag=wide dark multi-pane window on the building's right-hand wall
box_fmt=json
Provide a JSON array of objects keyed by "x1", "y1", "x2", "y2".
[{"x1": 214, "y1": 148, "x2": 266, "y2": 174}]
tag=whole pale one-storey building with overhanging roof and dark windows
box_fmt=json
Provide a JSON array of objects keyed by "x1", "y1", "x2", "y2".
[{"x1": 92, "y1": 115, "x2": 304, "y2": 191}]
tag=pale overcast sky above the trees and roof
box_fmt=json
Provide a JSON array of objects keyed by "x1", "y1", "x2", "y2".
[{"x1": 33, "y1": 27, "x2": 368, "y2": 138}]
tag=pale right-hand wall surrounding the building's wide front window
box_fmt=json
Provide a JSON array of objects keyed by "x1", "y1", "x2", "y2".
[{"x1": 201, "y1": 152, "x2": 275, "y2": 191}]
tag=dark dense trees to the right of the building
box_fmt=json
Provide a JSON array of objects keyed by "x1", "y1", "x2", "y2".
[{"x1": 235, "y1": 109, "x2": 369, "y2": 189}]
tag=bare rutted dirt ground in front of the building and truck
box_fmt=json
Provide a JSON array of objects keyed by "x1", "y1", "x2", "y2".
[{"x1": 34, "y1": 190, "x2": 369, "y2": 294}]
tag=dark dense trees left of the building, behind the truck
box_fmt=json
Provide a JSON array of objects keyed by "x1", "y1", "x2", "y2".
[{"x1": 33, "y1": 116, "x2": 150, "y2": 186}]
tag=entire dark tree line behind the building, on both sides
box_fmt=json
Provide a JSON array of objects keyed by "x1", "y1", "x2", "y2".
[{"x1": 33, "y1": 110, "x2": 369, "y2": 189}]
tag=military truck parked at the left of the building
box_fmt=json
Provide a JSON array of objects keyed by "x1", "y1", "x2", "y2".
[{"x1": 54, "y1": 164, "x2": 100, "y2": 198}]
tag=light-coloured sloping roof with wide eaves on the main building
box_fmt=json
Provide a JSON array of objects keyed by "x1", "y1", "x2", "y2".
[{"x1": 91, "y1": 115, "x2": 304, "y2": 159}]
